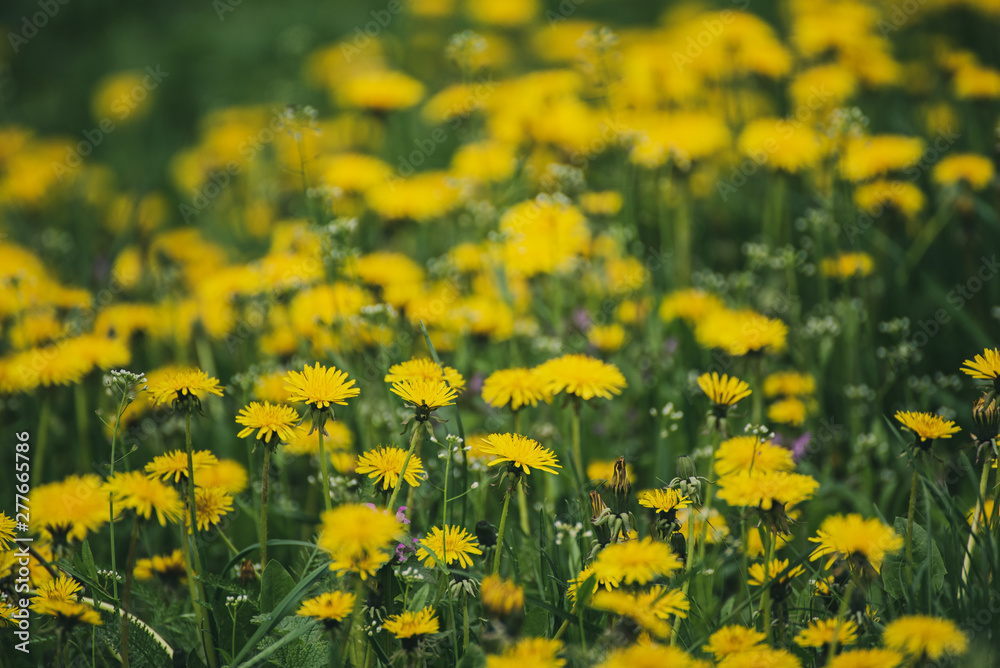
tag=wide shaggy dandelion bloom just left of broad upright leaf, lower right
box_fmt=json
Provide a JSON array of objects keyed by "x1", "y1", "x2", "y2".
[{"x1": 809, "y1": 513, "x2": 903, "y2": 572}]
